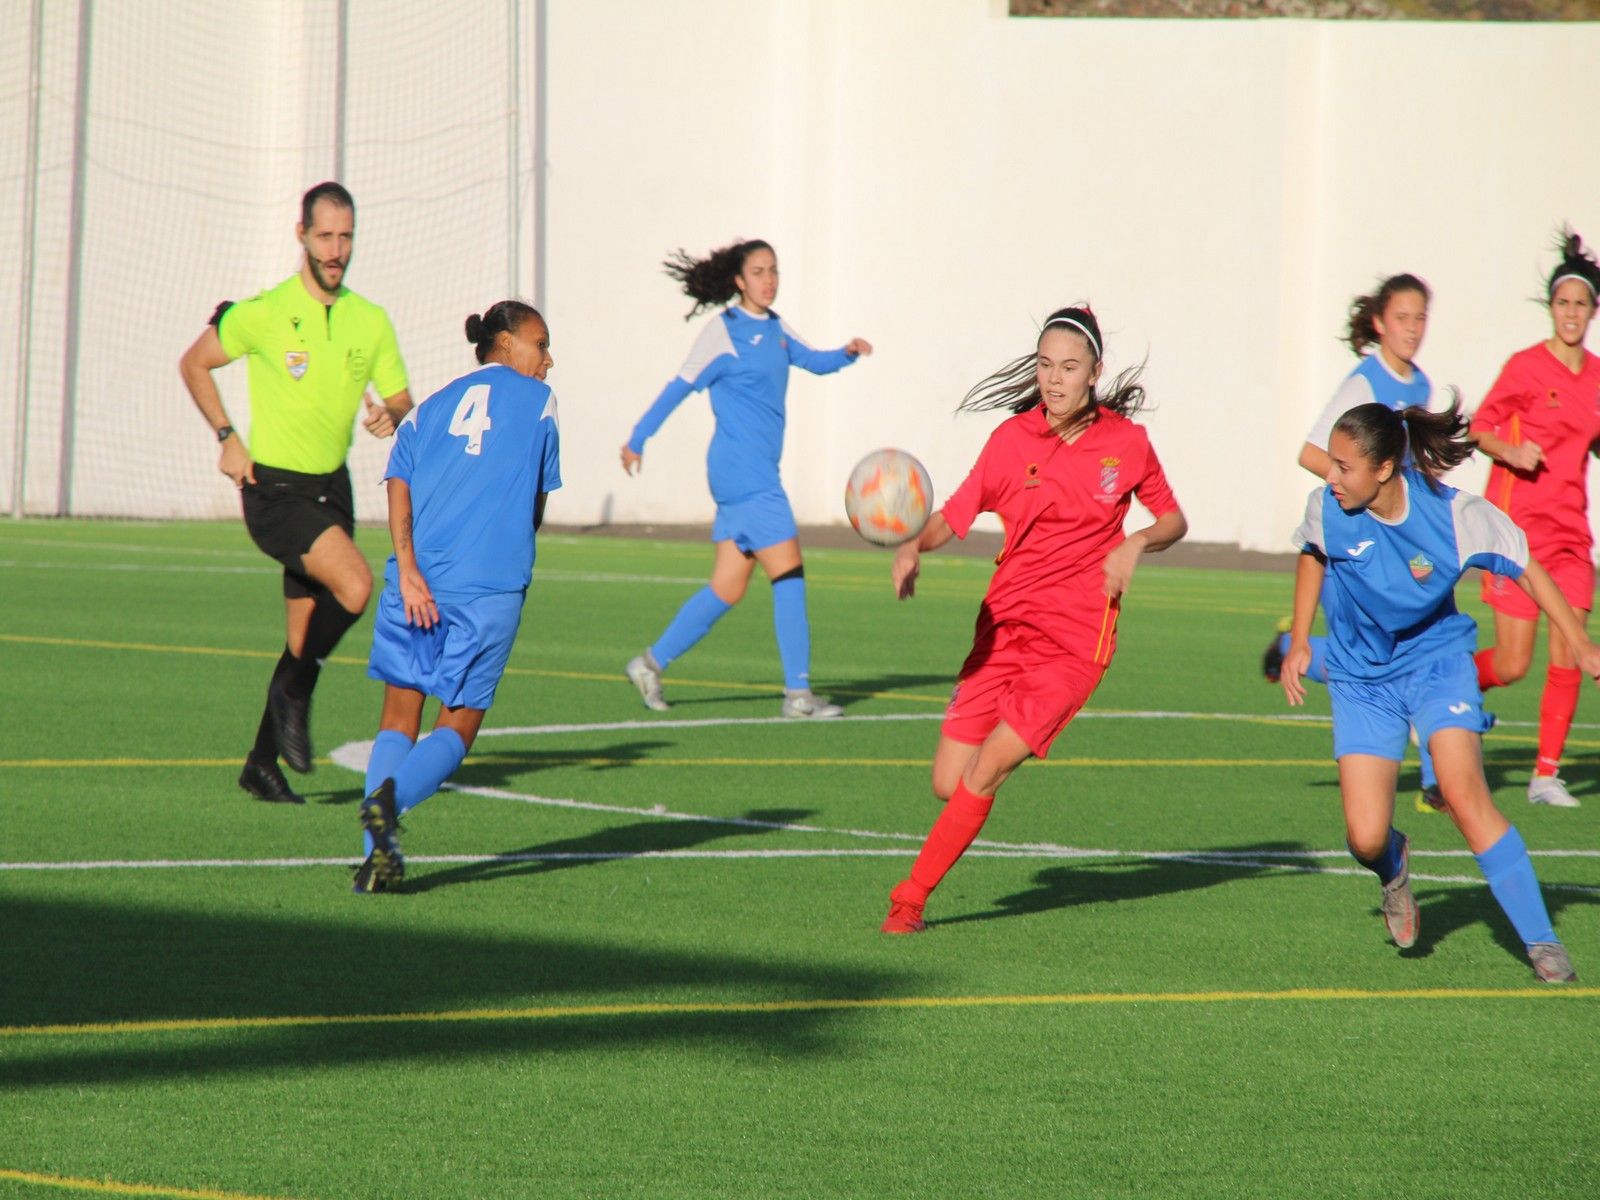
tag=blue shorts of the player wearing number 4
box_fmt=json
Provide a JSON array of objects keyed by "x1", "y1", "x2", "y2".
[{"x1": 366, "y1": 584, "x2": 523, "y2": 709}]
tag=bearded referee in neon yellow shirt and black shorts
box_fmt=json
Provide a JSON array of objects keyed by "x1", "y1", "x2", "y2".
[{"x1": 179, "y1": 182, "x2": 411, "y2": 805}]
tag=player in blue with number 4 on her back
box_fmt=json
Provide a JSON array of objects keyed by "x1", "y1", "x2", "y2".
[{"x1": 355, "y1": 301, "x2": 562, "y2": 891}]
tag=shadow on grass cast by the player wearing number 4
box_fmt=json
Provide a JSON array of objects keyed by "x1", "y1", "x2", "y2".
[{"x1": 400, "y1": 808, "x2": 811, "y2": 893}]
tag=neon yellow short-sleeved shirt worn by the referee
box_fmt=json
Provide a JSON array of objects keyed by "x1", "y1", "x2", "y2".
[{"x1": 216, "y1": 274, "x2": 406, "y2": 475}]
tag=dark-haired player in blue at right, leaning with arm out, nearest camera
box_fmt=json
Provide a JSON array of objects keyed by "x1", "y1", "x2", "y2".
[{"x1": 1282, "y1": 403, "x2": 1600, "y2": 982}]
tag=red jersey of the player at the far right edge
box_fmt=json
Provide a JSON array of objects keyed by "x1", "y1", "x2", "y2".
[{"x1": 1472, "y1": 342, "x2": 1600, "y2": 558}]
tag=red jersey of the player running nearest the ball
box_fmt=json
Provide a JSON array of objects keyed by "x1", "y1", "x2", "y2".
[{"x1": 942, "y1": 405, "x2": 1178, "y2": 666}]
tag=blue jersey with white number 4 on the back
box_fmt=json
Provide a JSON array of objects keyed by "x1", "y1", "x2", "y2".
[{"x1": 384, "y1": 363, "x2": 562, "y2": 602}]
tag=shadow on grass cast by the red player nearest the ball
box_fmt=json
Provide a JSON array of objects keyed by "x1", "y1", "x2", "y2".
[{"x1": 928, "y1": 842, "x2": 1306, "y2": 925}]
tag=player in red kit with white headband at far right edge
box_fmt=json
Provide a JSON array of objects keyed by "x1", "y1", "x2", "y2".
[{"x1": 1472, "y1": 230, "x2": 1600, "y2": 808}]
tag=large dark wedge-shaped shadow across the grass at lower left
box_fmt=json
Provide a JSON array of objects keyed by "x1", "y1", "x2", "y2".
[{"x1": 0, "y1": 889, "x2": 917, "y2": 1093}]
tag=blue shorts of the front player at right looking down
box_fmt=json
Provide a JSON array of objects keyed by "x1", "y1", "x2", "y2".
[{"x1": 1328, "y1": 653, "x2": 1490, "y2": 762}]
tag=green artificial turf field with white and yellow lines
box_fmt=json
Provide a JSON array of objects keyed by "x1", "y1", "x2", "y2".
[{"x1": 0, "y1": 522, "x2": 1600, "y2": 1200}]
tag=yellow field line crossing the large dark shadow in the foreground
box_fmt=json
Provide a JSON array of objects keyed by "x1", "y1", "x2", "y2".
[{"x1": 0, "y1": 984, "x2": 1600, "y2": 1038}]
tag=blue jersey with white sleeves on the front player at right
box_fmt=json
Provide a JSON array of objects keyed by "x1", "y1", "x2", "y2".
[{"x1": 1294, "y1": 469, "x2": 1528, "y2": 682}]
